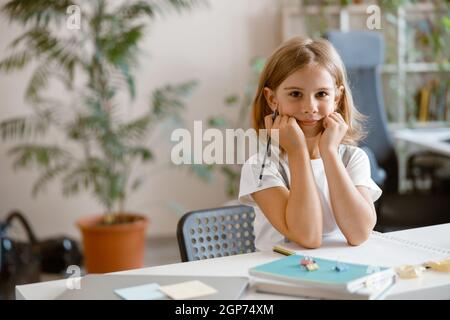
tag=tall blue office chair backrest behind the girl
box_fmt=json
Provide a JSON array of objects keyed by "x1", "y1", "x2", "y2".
[{"x1": 326, "y1": 31, "x2": 398, "y2": 191}]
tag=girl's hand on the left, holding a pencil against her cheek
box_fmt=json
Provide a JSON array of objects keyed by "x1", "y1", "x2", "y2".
[{"x1": 264, "y1": 115, "x2": 306, "y2": 153}]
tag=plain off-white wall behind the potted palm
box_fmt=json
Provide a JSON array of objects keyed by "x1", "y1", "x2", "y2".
[{"x1": 0, "y1": 0, "x2": 281, "y2": 237}]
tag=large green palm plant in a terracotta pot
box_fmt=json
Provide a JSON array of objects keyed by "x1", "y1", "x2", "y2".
[{"x1": 0, "y1": 0, "x2": 202, "y2": 273}]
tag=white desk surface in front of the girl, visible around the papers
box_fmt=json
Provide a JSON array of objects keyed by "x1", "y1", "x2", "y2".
[{"x1": 16, "y1": 223, "x2": 450, "y2": 300}]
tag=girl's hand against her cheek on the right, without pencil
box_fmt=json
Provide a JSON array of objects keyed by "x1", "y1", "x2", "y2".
[{"x1": 319, "y1": 112, "x2": 348, "y2": 155}]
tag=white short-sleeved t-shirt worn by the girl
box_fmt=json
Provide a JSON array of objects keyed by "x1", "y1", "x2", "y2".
[{"x1": 239, "y1": 144, "x2": 381, "y2": 250}]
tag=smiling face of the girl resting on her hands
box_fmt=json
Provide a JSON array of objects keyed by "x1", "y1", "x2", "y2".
[{"x1": 264, "y1": 64, "x2": 343, "y2": 138}]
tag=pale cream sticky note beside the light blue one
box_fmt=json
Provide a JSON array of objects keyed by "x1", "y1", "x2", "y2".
[{"x1": 159, "y1": 280, "x2": 217, "y2": 300}]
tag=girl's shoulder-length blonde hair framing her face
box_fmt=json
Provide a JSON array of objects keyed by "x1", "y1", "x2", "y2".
[{"x1": 252, "y1": 37, "x2": 365, "y2": 145}]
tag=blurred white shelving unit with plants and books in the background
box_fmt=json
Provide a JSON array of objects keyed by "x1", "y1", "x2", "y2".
[{"x1": 282, "y1": 0, "x2": 450, "y2": 129}]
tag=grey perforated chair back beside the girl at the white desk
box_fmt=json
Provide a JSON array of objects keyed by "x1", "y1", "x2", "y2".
[{"x1": 177, "y1": 205, "x2": 255, "y2": 262}]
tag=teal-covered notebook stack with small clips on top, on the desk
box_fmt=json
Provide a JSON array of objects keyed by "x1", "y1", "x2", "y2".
[{"x1": 249, "y1": 254, "x2": 395, "y2": 292}]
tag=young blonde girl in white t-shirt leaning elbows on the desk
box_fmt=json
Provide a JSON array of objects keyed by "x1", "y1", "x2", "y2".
[{"x1": 239, "y1": 37, "x2": 381, "y2": 250}]
